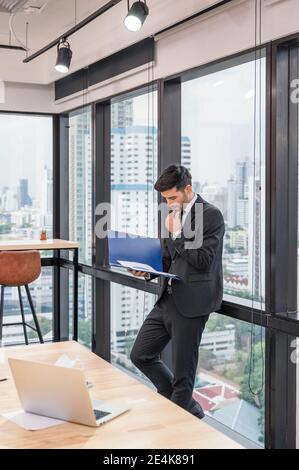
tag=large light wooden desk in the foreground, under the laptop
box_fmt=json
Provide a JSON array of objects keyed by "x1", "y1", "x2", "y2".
[{"x1": 0, "y1": 341, "x2": 244, "y2": 449}]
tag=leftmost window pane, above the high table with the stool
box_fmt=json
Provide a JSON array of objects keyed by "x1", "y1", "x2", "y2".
[{"x1": 0, "y1": 114, "x2": 53, "y2": 240}]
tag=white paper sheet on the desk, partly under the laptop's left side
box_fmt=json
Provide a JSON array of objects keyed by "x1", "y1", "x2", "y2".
[{"x1": 3, "y1": 410, "x2": 65, "y2": 431}]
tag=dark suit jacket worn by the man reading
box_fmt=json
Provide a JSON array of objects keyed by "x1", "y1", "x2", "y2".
[{"x1": 152, "y1": 195, "x2": 224, "y2": 317}]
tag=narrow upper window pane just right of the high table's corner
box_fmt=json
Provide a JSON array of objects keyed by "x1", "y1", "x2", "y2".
[{"x1": 69, "y1": 106, "x2": 93, "y2": 264}]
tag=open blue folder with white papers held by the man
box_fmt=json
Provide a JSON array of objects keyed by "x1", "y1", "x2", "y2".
[{"x1": 108, "y1": 230, "x2": 179, "y2": 279}]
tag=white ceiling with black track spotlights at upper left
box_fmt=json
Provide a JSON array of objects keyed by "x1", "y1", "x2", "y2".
[{"x1": 0, "y1": 0, "x2": 230, "y2": 84}]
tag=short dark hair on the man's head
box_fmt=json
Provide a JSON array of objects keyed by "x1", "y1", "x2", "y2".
[{"x1": 154, "y1": 165, "x2": 192, "y2": 193}]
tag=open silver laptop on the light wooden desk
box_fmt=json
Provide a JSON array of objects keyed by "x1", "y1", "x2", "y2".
[{"x1": 8, "y1": 358, "x2": 129, "y2": 427}]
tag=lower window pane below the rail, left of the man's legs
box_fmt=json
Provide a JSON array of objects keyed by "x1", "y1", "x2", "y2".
[{"x1": 110, "y1": 282, "x2": 156, "y2": 381}]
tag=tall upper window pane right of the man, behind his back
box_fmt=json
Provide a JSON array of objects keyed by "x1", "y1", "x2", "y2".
[{"x1": 182, "y1": 58, "x2": 265, "y2": 307}]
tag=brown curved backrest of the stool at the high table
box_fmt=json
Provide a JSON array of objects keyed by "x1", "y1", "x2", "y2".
[{"x1": 0, "y1": 250, "x2": 41, "y2": 286}]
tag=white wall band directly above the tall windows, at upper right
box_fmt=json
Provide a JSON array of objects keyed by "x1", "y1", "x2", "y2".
[{"x1": 55, "y1": 0, "x2": 299, "y2": 112}]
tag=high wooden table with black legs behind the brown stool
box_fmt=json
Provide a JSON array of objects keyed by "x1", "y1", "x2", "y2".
[{"x1": 0, "y1": 238, "x2": 79, "y2": 340}]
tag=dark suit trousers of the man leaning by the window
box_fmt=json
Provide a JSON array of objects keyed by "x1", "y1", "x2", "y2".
[{"x1": 130, "y1": 291, "x2": 209, "y2": 411}]
